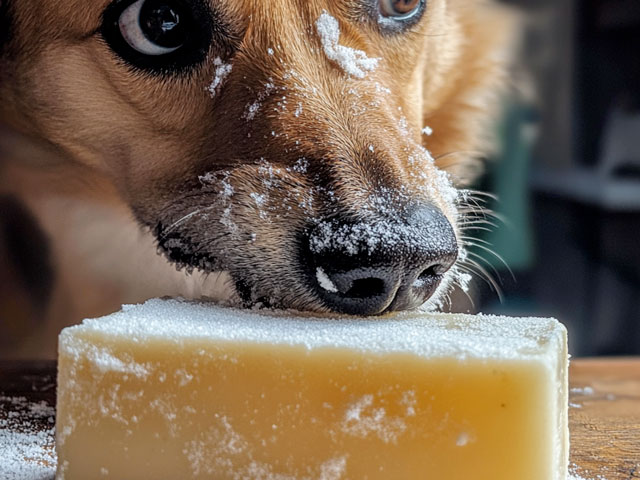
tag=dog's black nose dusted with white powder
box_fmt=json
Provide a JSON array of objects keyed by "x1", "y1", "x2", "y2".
[{"x1": 304, "y1": 206, "x2": 458, "y2": 315}]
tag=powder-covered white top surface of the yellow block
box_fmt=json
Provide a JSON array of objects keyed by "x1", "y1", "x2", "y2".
[{"x1": 61, "y1": 299, "x2": 566, "y2": 359}]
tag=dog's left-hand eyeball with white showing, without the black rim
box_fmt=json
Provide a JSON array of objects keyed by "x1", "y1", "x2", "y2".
[{"x1": 118, "y1": 0, "x2": 186, "y2": 55}]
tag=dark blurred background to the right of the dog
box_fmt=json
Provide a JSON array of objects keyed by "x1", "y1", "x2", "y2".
[{"x1": 464, "y1": 0, "x2": 640, "y2": 355}]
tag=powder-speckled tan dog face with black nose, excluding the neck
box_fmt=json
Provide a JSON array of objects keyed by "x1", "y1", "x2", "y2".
[{"x1": 0, "y1": 0, "x2": 510, "y2": 313}]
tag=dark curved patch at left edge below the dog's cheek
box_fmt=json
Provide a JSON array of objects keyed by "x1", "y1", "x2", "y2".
[{"x1": 0, "y1": 195, "x2": 55, "y2": 313}]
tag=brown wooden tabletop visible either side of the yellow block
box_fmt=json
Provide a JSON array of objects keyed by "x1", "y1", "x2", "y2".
[{"x1": 0, "y1": 359, "x2": 640, "y2": 480}]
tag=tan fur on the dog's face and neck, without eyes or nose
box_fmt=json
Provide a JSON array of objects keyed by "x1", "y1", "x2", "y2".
[{"x1": 0, "y1": 0, "x2": 506, "y2": 355}]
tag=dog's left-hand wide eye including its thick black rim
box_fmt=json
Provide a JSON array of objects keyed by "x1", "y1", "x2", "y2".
[{"x1": 102, "y1": 0, "x2": 212, "y2": 71}]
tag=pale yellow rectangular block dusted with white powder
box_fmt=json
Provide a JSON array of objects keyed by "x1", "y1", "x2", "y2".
[{"x1": 56, "y1": 300, "x2": 568, "y2": 480}]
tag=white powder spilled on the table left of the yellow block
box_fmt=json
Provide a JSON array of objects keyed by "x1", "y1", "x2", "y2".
[{"x1": 0, "y1": 397, "x2": 56, "y2": 480}]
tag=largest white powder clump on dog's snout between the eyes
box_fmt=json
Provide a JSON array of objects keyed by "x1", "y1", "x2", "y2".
[{"x1": 316, "y1": 11, "x2": 380, "y2": 78}]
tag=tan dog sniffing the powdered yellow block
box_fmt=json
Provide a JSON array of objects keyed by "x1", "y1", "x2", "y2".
[{"x1": 0, "y1": 0, "x2": 511, "y2": 357}]
